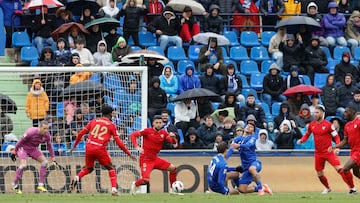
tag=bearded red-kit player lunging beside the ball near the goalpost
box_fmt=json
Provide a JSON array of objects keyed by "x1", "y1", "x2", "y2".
[{"x1": 130, "y1": 116, "x2": 180, "y2": 194}]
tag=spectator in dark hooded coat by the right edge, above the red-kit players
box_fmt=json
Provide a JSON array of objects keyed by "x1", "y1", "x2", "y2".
[{"x1": 334, "y1": 52, "x2": 360, "y2": 87}]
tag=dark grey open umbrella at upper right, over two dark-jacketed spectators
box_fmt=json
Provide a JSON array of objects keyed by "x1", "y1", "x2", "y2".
[{"x1": 275, "y1": 16, "x2": 321, "y2": 34}]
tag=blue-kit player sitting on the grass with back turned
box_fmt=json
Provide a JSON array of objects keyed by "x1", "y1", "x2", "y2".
[{"x1": 207, "y1": 142, "x2": 239, "y2": 195}]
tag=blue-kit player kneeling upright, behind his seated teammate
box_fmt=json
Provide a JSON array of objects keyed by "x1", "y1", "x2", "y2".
[{"x1": 226, "y1": 123, "x2": 272, "y2": 195}]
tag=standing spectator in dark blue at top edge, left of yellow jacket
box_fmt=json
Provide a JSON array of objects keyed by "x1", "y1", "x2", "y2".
[{"x1": 259, "y1": 0, "x2": 285, "y2": 32}]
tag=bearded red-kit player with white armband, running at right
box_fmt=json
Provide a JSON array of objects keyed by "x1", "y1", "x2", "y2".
[{"x1": 297, "y1": 105, "x2": 354, "y2": 194}]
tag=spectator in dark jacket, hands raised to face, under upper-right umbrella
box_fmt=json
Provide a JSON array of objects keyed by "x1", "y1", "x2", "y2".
[{"x1": 279, "y1": 34, "x2": 306, "y2": 74}]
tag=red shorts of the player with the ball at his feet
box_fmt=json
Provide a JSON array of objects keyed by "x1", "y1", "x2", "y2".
[{"x1": 140, "y1": 157, "x2": 171, "y2": 179}]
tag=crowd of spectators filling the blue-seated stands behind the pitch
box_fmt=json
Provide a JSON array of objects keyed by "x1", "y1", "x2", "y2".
[{"x1": 0, "y1": 0, "x2": 360, "y2": 151}]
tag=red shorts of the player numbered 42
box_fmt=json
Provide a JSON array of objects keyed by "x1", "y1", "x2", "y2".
[{"x1": 85, "y1": 147, "x2": 111, "y2": 167}]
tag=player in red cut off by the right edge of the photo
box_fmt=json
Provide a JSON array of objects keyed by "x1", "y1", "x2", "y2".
[{"x1": 329, "y1": 105, "x2": 360, "y2": 194}]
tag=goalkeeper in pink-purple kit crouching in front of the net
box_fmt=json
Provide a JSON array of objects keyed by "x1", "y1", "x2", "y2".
[{"x1": 10, "y1": 121, "x2": 58, "y2": 194}]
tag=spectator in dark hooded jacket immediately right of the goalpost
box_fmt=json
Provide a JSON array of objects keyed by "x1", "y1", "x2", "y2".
[{"x1": 148, "y1": 76, "x2": 168, "y2": 120}]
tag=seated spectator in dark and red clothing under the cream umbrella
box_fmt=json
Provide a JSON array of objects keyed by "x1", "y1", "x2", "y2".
[{"x1": 180, "y1": 6, "x2": 200, "y2": 43}]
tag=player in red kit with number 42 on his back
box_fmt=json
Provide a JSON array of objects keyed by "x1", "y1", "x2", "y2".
[{"x1": 70, "y1": 105, "x2": 136, "y2": 196}]
